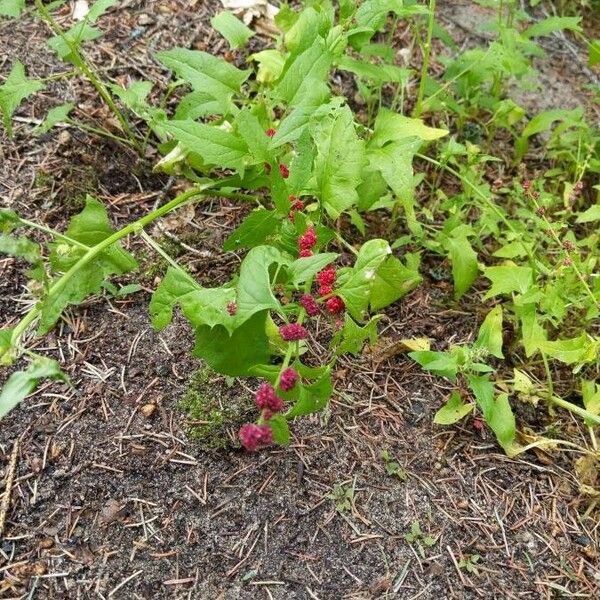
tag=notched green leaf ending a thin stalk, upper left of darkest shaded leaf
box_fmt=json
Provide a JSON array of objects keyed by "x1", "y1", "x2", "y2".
[{"x1": 148, "y1": 267, "x2": 235, "y2": 331}]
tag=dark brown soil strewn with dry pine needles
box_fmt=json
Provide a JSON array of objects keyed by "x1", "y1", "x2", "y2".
[{"x1": 0, "y1": 2, "x2": 600, "y2": 600}]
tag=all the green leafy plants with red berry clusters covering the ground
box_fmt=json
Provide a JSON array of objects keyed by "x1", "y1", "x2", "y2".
[{"x1": 0, "y1": 0, "x2": 600, "y2": 486}]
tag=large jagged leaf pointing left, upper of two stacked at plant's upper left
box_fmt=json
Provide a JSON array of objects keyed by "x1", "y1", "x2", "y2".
[{"x1": 156, "y1": 48, "x2": 250, "y2": 107}]
